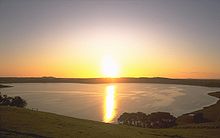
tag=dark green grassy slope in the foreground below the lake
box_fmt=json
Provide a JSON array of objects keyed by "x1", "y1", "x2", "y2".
[{"x1": 0, "y1": 106, "x2": 220, "y2": 138}]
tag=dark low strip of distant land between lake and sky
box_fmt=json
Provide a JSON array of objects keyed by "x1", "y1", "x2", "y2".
[{"x1": 0, "y1": 77, "x2": 220, "y2": 87}]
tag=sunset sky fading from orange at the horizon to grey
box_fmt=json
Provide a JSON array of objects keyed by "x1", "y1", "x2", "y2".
[{"x1": 0, "y1": 0, "x2": 220, "y2": 79}]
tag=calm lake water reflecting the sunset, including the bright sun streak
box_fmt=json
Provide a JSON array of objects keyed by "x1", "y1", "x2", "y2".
[{"x1": 0, "y1": 83, "x2": 220, "y2": 122}]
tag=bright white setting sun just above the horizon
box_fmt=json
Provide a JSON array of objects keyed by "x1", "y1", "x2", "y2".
[{"x1": 102, "y1": 57, "x2": 119, "y2": 78}]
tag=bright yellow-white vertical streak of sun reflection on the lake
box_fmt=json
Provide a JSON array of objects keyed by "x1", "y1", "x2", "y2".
[{"x1": 103, "y1": 85, "x2": 116, "y2": 123}]
